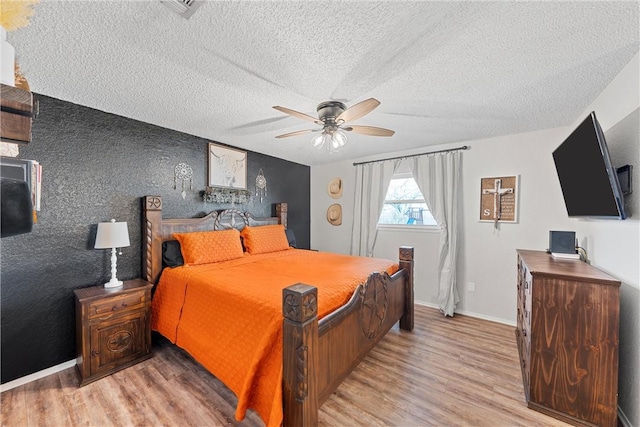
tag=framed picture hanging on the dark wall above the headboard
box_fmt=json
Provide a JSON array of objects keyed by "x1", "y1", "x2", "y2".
[{"x1": 208, "y1": 142, "x2": 247, "y2": 190}]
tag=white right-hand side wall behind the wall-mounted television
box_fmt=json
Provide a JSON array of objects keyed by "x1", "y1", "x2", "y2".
[{"x1": 575, "y1": 54, "x2": 640, "y2": 426}]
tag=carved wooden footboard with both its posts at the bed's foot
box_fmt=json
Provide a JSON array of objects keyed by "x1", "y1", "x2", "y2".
[{"x1": 282, "y1": 247, "x2": 413, "y2": 427}]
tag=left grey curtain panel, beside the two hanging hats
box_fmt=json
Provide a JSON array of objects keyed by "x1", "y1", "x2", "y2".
[{"x1": 351, "y1": 160, "x2": 400, "y2": 257}]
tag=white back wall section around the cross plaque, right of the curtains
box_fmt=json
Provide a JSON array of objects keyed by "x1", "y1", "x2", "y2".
[{"x1": 459, "y1": 129, "x2": 571, "y2": 323}]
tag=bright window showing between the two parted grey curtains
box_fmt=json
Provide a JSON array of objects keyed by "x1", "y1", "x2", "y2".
[{"x1": 378, "y1": 174, "x2": 437, "y2": 226}]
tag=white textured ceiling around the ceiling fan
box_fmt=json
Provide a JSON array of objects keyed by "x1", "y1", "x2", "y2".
[{"x1": 8, "y1": 0, "x2": 639, "y2": 165}]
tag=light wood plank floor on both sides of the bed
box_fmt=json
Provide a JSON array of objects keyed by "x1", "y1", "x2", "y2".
[{"x1": 1, "y1": 306, "x2": 567, "y2": 427}]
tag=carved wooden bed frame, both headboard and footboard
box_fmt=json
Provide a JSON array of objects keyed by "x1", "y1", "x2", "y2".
[{"x1": 142, "y1": 196, "x2": 414, "y2": 427}]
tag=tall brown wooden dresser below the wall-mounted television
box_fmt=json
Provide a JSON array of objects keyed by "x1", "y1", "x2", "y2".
[{"x1": 516, "y1": 250, "x2": 620, "y2": 427}]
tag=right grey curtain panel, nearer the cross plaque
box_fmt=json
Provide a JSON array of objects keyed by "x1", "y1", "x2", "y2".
[{"x1": 411, "y1": 151, "x2": 462, "y2": 316}]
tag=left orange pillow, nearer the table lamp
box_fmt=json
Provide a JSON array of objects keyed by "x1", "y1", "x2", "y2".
[{"x1": 173, "y1": 228, "x2": 244, "y2": 265}]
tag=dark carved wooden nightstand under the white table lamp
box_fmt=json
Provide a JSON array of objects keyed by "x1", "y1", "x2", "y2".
[{"x1": 74, "y1": 279, "x2": 153, "y2": 386}]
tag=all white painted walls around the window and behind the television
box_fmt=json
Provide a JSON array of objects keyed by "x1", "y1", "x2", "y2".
[{"x1": 311, "y1": 50, "x2": 640, "y2": 425}]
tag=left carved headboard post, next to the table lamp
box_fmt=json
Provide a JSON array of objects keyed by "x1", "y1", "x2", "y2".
[{"x1": 142, "y1": 196, "x2": 162, "y2": 284}]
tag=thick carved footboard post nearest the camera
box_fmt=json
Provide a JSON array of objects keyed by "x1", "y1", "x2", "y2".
[{"x1": 282, "y1": 283, "x2": 319, "y2": 427}]
